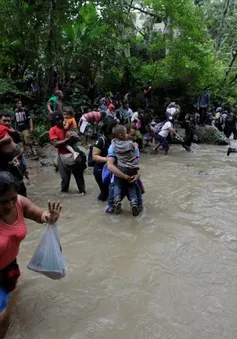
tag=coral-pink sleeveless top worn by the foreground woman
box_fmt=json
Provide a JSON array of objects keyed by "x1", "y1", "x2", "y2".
[{"x1": 0, "y1": 198, "x2": 27, "y2": 270}]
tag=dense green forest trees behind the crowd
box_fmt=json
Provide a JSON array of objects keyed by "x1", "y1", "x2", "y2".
[{"x1": 0, "y1": 0, "x2": 237, "y2": 114}]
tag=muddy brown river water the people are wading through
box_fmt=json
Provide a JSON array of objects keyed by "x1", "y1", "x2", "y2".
[{"x1": 7, "y1": 145, "x2": 237, "y2": 339}]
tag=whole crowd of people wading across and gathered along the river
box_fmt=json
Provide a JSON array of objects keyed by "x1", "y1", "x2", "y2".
[{"x1": 0, "y1": 89, "x2": 237, "y2": 339}]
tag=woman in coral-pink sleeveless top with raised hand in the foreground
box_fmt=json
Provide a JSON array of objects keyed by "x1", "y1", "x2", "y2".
[{"x1": 0, "y1": 172, "x2": 62, "y2": 339}]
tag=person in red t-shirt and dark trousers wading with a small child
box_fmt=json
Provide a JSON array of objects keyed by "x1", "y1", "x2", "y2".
[{"x1": 49, "y1": 112, "x2": 86, "y2": 195}]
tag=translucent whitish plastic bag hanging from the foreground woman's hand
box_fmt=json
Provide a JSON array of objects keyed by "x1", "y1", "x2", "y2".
[{"x1": 27, "y1": 225, "x2": 66, "y2": 280}]
